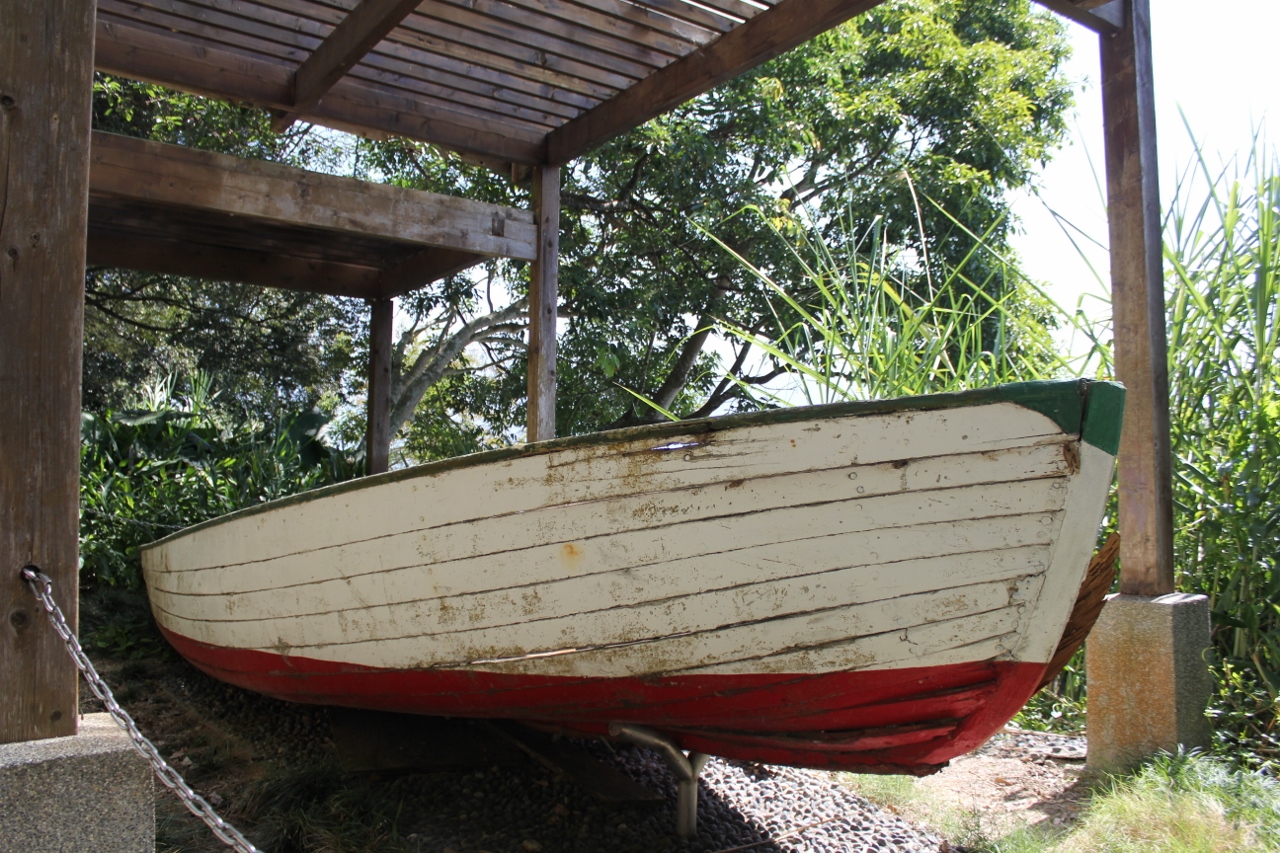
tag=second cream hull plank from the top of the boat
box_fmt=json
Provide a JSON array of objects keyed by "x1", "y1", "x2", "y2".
[{"x1": 152, "y1": 443, "x2": 1068, "y2": 603}]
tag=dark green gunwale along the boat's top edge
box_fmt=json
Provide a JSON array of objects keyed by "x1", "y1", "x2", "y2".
[{"x1": 138, "y1": 379, "x2": 1124, "y2": 555}]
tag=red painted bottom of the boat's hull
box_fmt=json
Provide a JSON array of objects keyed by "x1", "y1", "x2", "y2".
[{"x1": 161, "y1": 629, "x2": 1044, "y2": 774}]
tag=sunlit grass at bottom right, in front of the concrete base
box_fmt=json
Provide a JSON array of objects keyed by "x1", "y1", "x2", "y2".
[{"x1": 847, "y1": 754, "x2": 1280, "y2": 853}]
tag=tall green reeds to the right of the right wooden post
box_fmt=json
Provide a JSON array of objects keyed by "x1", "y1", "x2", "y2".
[{"x1": 1165, "y1": 131, "x2": 1280, "y2": 763}]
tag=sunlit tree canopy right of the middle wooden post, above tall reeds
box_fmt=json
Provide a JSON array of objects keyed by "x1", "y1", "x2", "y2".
[{"x1": 547, "y1": 0, "x2": 1070, "y2": 434}]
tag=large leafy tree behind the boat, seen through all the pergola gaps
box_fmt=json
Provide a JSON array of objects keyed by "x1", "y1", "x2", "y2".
[{"x1": 85, "y1": 0, "x2": 1070, "y2": 452}]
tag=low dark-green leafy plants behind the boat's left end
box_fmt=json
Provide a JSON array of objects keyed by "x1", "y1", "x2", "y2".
[{"x1": 81, "y1": 374, "x2": 362, "y2": 589}]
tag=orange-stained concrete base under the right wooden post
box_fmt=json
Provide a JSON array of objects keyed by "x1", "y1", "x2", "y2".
[{"x1": 1085, "y1": 593, "x2": 1213, "y2": 774}]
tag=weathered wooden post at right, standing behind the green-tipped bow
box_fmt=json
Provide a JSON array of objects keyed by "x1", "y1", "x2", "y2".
[{"x1": 1101, "y1": 0, "x2": 1174, "y2": 596}]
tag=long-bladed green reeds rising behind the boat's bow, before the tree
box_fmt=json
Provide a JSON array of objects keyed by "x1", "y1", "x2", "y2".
[{"x1": 701, "y1": 192, "x2": 1073, "y2": 406}]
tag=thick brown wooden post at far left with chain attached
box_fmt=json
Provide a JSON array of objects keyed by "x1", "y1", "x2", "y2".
[{"x1": 0, "y1": 0, "x2": 95, "y2": 743}]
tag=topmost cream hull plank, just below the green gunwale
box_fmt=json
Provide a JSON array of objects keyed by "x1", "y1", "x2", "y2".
[{"x1": 152, "y1": 403, "x2": 1064, "y2": 573}]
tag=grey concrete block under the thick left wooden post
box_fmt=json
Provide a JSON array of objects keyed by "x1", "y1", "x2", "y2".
[{"x1": 0, "y1": 713, "x2": 155, "y2": 853}]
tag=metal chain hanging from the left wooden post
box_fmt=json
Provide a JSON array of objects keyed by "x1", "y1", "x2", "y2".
[{"x1": 22, "y1": 566, "x2": 260, "y2": 853}]
